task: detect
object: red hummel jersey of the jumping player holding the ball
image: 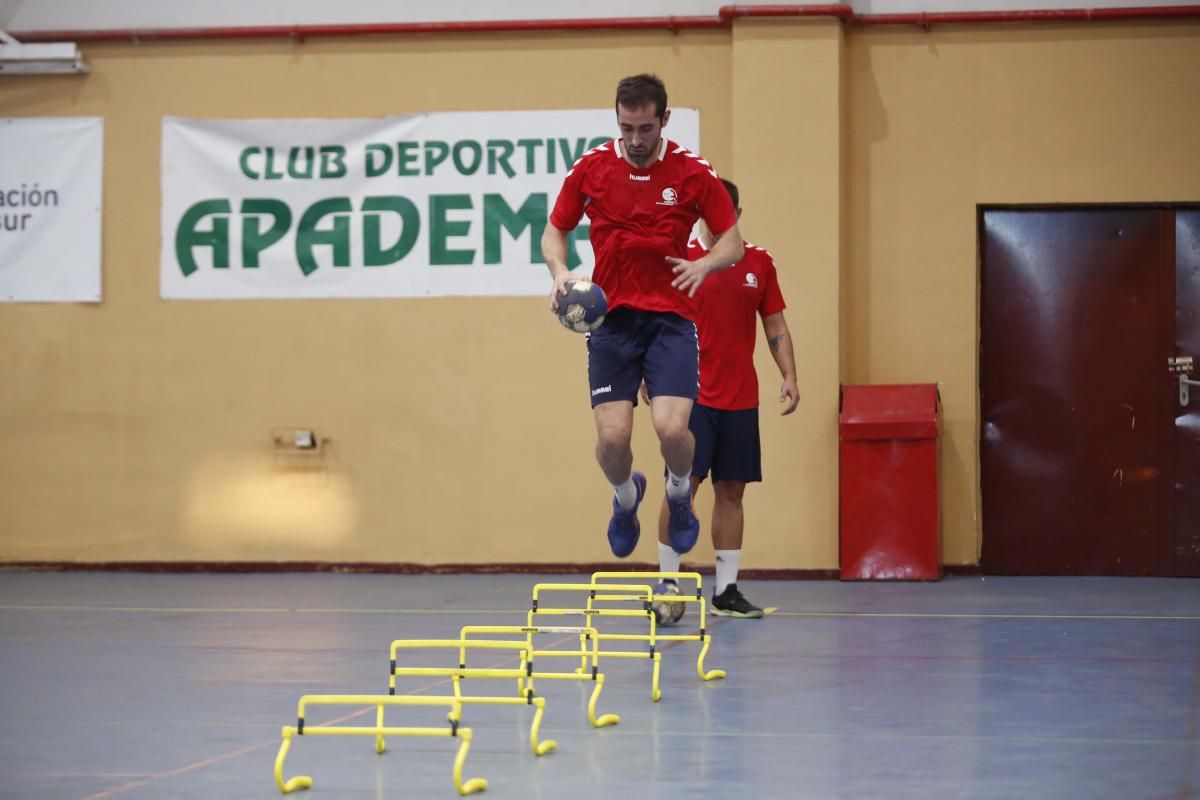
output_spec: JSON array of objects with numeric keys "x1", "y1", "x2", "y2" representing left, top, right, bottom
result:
[{"x1": 550, "y1": 139, "x2": 737, "y2": 319}]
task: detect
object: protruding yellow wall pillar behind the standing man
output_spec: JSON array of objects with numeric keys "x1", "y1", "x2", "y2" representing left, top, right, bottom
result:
[{"x1": 733, "y1": 19, "x2": 842, "y2": 569}]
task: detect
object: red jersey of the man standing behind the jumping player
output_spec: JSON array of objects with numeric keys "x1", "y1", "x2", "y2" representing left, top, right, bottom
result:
[{"x1": 688, "y1": 242, "x2": 787, "y2": 411}]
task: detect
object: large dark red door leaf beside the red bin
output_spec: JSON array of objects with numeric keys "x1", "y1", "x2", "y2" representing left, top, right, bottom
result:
[{"x1": 979, "y1": 207, "x2": 1180, "y2": 575}]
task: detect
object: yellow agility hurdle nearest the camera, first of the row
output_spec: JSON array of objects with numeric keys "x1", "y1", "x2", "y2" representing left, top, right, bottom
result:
[{"x1": 275, "y1": 694, "x2": 487, "y2": 795}]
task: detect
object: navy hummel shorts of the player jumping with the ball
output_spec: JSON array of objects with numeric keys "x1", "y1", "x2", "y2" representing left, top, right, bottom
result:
[{"x1": 588, "y1": 307, "x2": 700, "y2": 408}]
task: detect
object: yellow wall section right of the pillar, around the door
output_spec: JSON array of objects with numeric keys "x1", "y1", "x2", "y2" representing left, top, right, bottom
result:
[{"x1": 845, "y1": 23, "x2": 1200, "y2": 564}]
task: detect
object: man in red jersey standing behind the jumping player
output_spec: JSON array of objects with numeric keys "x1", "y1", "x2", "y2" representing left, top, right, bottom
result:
[{"x1": 659, "y1": 180, "x2": 800, "y2": 619}]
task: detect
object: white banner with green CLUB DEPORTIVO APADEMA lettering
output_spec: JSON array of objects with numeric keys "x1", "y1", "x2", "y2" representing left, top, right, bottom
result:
[{"x1": 161, "y1": 108, "x2": 700, "y2": 299}]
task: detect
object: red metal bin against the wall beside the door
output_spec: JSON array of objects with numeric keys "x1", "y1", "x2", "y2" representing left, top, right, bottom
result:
[{"x1": 839, "y1": 384, "x2": 942, "y2": 581}]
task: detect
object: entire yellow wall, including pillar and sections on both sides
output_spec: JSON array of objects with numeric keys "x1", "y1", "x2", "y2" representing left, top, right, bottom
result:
[{"x1": 0, "y1": 20, "x2": 1200, "y2": 569}]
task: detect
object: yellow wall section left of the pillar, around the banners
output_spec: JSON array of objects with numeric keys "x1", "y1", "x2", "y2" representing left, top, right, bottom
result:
[{"x1": 0, "y1": 31, "x2": 730, "y2": 563}]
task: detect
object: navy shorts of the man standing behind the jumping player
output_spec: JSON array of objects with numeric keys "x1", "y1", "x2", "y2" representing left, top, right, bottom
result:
[{"x1": 688, "y1": 403, "x2": 762, "y2": 483}]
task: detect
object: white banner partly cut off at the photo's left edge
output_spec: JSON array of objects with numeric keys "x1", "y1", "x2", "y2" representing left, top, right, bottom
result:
[{"x1": 0, "y1": 116, "x2": 104, "y2": 302}]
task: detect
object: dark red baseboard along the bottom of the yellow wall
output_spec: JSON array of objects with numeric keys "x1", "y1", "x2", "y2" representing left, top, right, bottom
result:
[{"x1": 0, "y1": 561, "x2": 982, "y2": 581}]
